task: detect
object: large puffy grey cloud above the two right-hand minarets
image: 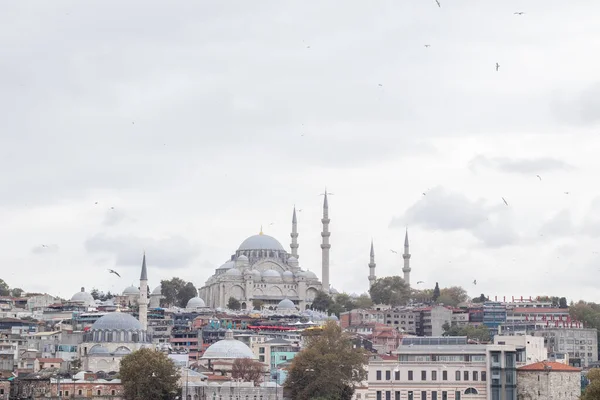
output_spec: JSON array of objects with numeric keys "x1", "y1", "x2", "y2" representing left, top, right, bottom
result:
[{"x1": 390, "y1": 187, "x2": 518, "y2": 247}]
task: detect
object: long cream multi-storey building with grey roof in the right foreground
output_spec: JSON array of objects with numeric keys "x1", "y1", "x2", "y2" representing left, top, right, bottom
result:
[{"x1": 368, "y1": 337, "x2": 517, "y2": 400}]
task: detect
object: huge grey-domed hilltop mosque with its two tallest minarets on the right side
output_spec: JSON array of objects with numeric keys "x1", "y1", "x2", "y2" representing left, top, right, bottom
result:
[{"x1": 199, "y1": 193, "x2": 333, "y2": 310}]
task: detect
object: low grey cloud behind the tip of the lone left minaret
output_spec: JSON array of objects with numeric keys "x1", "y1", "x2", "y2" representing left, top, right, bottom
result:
[{"x1": 85, "y1": 234, "x2": 199, "y2": 269}]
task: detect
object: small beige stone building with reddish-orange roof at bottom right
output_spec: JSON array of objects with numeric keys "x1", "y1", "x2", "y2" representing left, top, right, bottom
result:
[{"x1": 517, "y1": 361, "x2": 581, "y2": 400}]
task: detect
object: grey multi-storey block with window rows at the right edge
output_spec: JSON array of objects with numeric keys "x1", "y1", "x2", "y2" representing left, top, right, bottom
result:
[{"x1": 533, "y1": 327, "x2": 598, "y2": 368}]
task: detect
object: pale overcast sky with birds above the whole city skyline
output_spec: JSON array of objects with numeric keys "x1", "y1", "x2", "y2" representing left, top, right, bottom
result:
[{"x1": 0, "y1": 0, "x2": 600, "y2": 301}]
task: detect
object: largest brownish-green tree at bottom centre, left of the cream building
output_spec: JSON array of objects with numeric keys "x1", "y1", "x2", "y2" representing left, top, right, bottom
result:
[{"x1": 285, "y1": 322, "x2": 368, "y2": 400}]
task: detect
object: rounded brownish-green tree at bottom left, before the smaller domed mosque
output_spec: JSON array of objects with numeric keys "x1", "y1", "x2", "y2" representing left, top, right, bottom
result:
[{"x1": 119, "y1": 349, "x2": 179, "y2": 400}]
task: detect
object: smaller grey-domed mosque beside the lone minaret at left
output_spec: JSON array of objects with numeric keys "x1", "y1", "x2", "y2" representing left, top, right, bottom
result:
[{"x1": 79, "y1": 312, "x2": 152, "y2": 372}]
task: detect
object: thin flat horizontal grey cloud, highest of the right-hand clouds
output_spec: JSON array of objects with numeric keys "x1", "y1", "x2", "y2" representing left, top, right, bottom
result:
[{"x1": 469, "y1": 154, "x2": 573, "y2": 175}]
